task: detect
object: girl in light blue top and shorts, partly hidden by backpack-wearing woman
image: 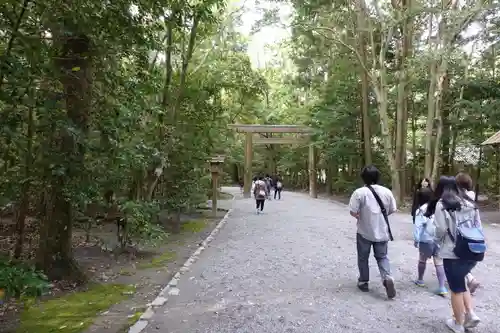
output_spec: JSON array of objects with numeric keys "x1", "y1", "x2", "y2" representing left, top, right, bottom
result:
[{"x1": 413, "y1": 188, "x2": 448, "y2": 296}]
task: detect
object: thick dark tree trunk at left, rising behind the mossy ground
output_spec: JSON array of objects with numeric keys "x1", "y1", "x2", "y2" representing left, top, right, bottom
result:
[{"x1": 36, "y1": 31, "x2": 92, "y2": 282}]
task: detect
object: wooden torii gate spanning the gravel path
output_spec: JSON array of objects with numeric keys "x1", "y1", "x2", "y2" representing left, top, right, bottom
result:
[{"x1": 229, "y1": 124, "x2": 318, "y2": 198}]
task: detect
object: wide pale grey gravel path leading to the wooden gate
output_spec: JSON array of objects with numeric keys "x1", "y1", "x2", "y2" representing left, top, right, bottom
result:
[{"x1": 145, "y1": 189, "x2": 500, "y2": 333}]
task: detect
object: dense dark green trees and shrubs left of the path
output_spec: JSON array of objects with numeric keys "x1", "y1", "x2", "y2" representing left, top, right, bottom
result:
[{"x1": 0, "y1": 0, "x2": 266, "y2": 287}]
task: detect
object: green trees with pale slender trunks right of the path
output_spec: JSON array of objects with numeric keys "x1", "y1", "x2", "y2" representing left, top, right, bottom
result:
[{"x1": 272, "y1": 0, "x2": 500, "y2": 202}]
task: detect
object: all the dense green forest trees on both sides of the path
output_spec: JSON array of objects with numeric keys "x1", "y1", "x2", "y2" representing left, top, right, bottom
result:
[{"x1": 0, "y1": 0, "x2": 500, "y2": 281}]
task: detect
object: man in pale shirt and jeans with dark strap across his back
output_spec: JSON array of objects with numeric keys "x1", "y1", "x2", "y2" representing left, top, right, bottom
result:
[{"x1": 349, "y1": 165, "x2": 396, "y2": 299}]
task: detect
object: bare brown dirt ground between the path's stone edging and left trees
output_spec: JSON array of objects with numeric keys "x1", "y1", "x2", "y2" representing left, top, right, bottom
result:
[{"x1": 0, "y1": 205, "x2": 227, "y2": 333}]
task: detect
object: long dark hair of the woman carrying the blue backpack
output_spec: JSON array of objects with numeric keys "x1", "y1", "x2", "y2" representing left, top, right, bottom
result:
[{"x1": 425, "y1": 176, "x2": 475, "y2": 217}]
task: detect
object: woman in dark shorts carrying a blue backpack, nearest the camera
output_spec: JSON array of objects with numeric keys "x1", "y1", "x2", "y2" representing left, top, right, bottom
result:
[{"x1": 425, "y1": 177, "x2": 486, "y2": 333}]
